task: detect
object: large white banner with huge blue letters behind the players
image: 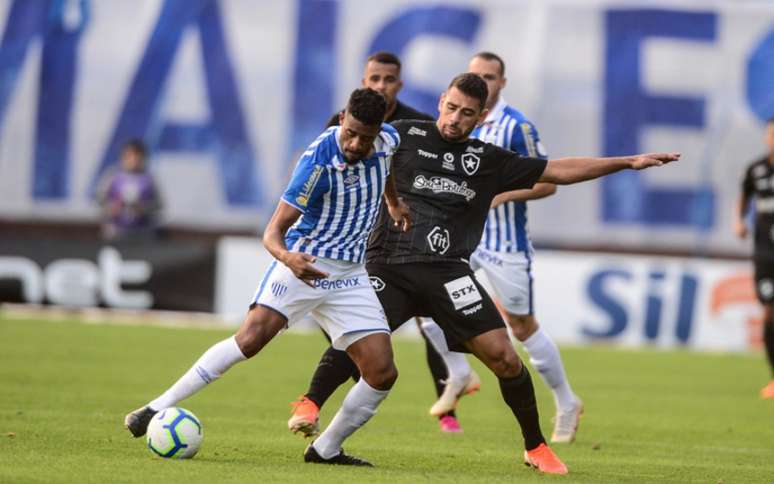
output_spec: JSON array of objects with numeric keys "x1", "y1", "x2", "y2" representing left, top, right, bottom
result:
[{"x1": 0, "y1": 0, "x2": 774, "y2": 255}]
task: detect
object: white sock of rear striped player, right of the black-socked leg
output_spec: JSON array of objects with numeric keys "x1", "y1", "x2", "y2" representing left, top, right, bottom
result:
[{"x1": 522, "y1": 327, "x2": 576, "y2": 411}]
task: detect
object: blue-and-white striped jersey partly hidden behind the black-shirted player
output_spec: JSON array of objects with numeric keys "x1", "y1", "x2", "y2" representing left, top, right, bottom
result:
[{"x1": 470, "y1": 98, "x2": 548, "y2": 253}]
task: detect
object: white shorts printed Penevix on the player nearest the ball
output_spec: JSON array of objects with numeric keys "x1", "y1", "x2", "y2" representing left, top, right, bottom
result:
[{"x1": 253, "y1": 257, "x2": 390, "y2": 350}]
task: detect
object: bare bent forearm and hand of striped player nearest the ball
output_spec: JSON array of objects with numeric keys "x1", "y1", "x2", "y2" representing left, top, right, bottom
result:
[{"x1": 263, "y1": 201, "x2": 328, "y2": 287}]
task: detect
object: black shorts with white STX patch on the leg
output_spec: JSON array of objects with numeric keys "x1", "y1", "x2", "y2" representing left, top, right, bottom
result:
[{"x1": 366, "y1": 261, "x2": 505, "y2": 351}]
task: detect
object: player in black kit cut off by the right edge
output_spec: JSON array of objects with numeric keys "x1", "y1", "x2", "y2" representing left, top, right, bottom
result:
[{"x1": 734, "y1": 118, "x2": 774, "y2": 399}]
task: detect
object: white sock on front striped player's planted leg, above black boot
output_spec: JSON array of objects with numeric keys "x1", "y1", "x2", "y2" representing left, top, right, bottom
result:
[{"x1": 314, "y1": 378, "x2": 390, "y2": 459}]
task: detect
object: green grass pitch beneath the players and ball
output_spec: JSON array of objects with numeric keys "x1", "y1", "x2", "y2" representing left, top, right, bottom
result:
[{"x1": 0, "y1": 316, "x2": 774, "y2": 483}]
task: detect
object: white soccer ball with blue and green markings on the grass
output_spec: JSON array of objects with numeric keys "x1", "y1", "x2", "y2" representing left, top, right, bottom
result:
[{"x1": 148, "y1": 407, "x2": 204, "y2": 459}]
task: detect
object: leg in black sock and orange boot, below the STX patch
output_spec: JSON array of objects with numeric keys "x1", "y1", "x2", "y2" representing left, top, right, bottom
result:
[{"x1": 466, "y1": 328, "x2": 567, "y2": 474}]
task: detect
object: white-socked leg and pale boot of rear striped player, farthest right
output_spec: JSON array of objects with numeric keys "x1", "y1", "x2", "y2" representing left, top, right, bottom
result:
[{"x1": 498, "y1": 306, "x2": 583, "y2": 443}]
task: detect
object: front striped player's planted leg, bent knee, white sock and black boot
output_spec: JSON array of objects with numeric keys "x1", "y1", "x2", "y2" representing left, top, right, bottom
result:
[{"x1": 304, "y1": 332, "x2": 398, "y2": 466}]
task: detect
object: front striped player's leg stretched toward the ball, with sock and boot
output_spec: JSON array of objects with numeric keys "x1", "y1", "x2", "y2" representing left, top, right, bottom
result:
[{"x1": 124, "y1": 305, "x2": 288, "y2": 437}]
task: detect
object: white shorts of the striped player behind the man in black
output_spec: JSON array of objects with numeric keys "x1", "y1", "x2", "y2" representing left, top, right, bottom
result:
[{"x1": 470, "y1": 247, "x2": 533, "y2": 316}]
